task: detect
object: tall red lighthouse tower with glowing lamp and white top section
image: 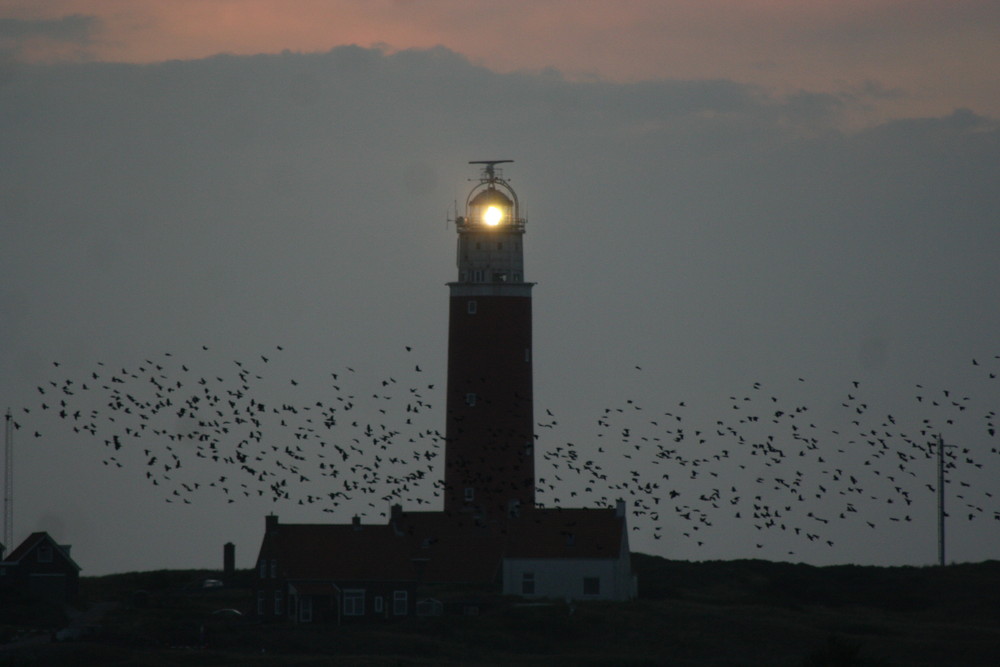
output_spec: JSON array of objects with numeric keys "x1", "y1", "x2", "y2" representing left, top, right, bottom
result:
[{"x1": 444, "y1": 160, "x2": 535, "y2": 517}]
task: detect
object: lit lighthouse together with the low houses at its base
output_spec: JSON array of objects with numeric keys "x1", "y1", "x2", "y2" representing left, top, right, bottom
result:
[{"x1": 254, "y1": 160, "x2": 636, "y2": 623}]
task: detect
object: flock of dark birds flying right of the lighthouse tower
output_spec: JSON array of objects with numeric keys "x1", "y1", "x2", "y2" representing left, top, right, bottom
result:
[{"x1": 539, "y1": 356, "x2": 1000, "y2": 555}]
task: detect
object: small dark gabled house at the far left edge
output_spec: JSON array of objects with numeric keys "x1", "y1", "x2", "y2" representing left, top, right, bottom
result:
[{"x1": 0, "y1": 532, "x2": 80, "y2": 601}]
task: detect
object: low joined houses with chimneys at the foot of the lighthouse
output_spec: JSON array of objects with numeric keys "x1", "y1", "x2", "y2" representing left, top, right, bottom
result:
[{"x1": 254, "y1": 503, "x2": 635, "y2": 623}]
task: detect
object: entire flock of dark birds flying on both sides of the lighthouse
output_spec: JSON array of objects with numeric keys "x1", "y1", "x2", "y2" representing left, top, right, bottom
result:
[{"x1": 15, "y1": 346, "x2": 1000, "y2": 554}]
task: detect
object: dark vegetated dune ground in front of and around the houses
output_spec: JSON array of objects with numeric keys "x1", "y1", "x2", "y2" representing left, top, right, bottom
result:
[{"x1": 0, "y1": 554, "x2": 1000, "y2": 667}]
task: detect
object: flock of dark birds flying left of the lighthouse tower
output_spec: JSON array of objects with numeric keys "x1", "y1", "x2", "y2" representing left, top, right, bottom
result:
[{"x1": 16, "y1": 346, "x2": 442, "y2": 514}]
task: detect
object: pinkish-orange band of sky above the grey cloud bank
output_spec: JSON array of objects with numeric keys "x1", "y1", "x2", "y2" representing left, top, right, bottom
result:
[{"x1": 0, "y1": 0, "x2": 1000, "y2": 118}]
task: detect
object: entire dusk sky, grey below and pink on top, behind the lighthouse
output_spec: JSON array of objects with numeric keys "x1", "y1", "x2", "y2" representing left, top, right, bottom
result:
[{"x1": 0, "y1": 0, "x2": 1000, "y2": 575}]
